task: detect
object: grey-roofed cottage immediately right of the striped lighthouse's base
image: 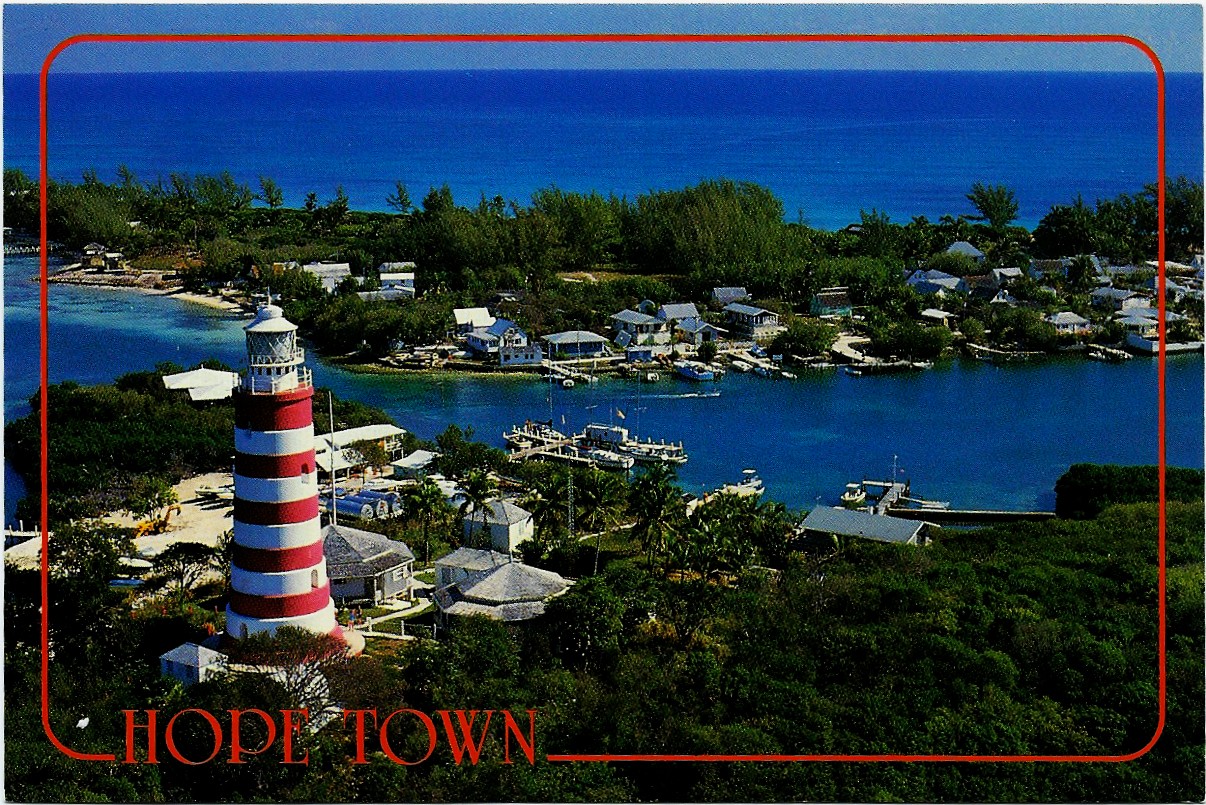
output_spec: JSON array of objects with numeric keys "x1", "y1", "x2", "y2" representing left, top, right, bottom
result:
[{"x1": 322, "y1": 524, "x2": 415, "y2": 603}]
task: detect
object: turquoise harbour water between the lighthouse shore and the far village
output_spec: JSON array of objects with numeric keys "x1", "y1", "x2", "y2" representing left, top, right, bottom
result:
[{"x1": 5, "y1": 258, "x2": 1204, "y2": 519}]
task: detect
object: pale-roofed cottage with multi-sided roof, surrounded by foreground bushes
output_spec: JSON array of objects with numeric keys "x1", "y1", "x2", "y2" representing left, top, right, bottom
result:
[{"x1": 432, "y1": 548, "x2": 573, "y2": 624}]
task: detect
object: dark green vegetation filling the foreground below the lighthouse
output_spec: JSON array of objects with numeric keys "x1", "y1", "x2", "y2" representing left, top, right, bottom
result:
[{"x1": 5, "y1": 487, "x2": 1206, "y2": 801}]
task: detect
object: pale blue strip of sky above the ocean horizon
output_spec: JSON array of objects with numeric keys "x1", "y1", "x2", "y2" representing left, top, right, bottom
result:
[{"x1": 2, "y1": 2, "x2": 1202, "y2": 74}]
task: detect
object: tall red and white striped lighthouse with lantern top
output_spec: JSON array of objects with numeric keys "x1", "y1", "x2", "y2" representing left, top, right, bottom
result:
[{"x1": 227, "y1": 304, "x2": 341, "y2": 640}]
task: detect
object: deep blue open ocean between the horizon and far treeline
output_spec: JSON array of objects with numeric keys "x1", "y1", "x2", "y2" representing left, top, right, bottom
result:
[{"x1": 4, "y1": 70, "x2": 1202, "y2": 228}]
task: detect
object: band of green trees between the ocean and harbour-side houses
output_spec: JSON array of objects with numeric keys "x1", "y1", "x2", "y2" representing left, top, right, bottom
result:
[{"x1": 5, "y1": 168, "x2": 1202, "y2": 356}]
